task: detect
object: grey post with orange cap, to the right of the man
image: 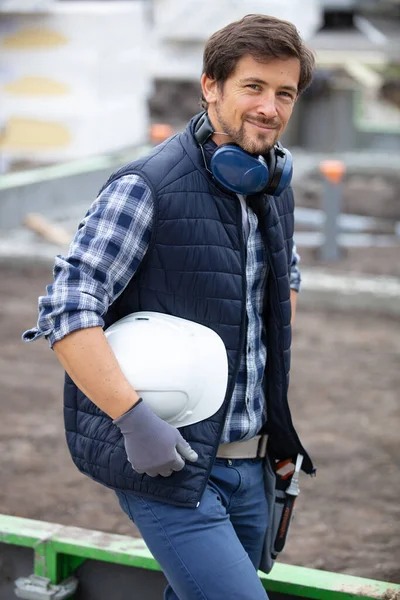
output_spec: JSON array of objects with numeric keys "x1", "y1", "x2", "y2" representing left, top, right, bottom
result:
[{"x1": 319, "y1": 160, "x2": 345, "y2": 261}]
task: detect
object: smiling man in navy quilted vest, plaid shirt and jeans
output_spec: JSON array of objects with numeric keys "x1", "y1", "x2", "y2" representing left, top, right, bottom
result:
[{"x1": 24, "y1": 15, "x2": 314, "y2": 600}]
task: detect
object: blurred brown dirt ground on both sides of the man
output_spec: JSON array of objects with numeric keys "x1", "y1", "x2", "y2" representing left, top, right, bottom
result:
[{"x1": 0, "y1": 264, "x2": 400, "y2": 583}]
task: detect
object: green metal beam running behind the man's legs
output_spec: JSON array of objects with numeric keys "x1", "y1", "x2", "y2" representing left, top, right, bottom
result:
[{"x1": 0, "y1": 515, "x2": 400, "y2": 600}]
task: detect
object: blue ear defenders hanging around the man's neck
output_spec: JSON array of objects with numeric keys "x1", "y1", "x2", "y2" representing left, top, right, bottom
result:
[{"x1": 194, "y1": 113, "x2": 293, "y2": 196}]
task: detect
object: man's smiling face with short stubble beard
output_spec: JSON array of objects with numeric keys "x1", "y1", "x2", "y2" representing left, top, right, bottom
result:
[{"x1": 201, "y1": 55, "x2": 300, "y2": 154}]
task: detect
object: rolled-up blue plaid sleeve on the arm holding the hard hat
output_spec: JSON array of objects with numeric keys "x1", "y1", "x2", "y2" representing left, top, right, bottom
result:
[{"x1": 22, "y1": 175, "x2": 154, "y2": 346}]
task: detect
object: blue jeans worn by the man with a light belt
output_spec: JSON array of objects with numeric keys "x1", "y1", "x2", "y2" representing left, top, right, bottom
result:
[{"x1": 117, "y1": 458, "x2": 268, "y2": 600}]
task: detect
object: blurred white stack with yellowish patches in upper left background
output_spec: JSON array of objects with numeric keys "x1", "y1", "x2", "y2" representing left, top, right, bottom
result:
[{"x1": 0, "y1": 1, "x2": 150, "y2": 162}]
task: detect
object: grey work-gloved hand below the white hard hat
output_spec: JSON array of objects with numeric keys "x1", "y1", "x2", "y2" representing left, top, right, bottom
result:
[{"x1": 113, "y1": 399, "x2": 198, "y2": 477}]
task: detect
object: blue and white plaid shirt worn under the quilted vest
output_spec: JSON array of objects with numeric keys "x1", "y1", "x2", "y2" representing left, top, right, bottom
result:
[{"x1": 23, "y1": 175, "x2": 300, "y2": 443}]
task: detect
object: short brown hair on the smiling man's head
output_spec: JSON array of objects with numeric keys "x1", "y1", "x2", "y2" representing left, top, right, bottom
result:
[{"x1": 201, "y1": 15, "x2": 315, "y2": 109}]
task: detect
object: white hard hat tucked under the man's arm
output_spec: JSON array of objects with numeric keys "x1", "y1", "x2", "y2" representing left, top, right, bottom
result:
[{"x1": 105, "y1": 312, "x2": 228, "y2": 427}]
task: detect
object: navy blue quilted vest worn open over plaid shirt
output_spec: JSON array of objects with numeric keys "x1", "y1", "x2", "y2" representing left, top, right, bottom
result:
[{"x1": 64, "y1": 116, "x2": 313, "y2": 507}]
